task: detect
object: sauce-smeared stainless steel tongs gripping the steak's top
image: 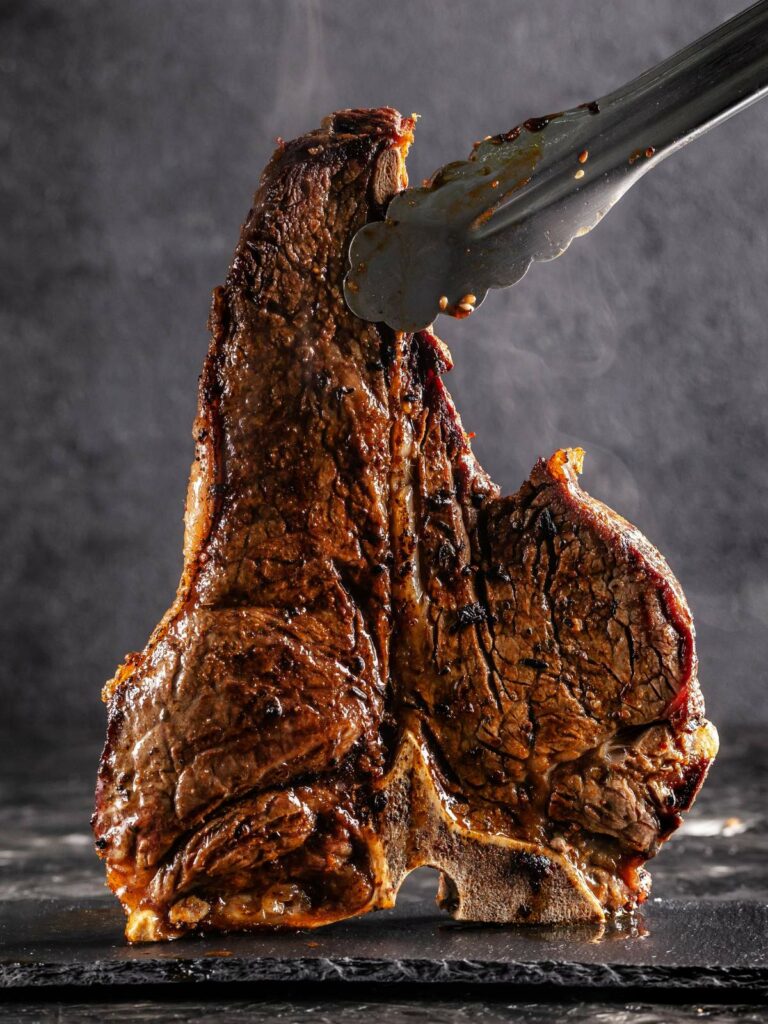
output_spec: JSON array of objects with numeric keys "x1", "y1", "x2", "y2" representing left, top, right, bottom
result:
[{"x1": 344, "y1": 0, "x2": 768, "y2": 331}]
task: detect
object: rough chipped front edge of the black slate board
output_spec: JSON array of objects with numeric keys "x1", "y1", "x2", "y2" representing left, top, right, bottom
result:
[{"x1": 0, "y1": 956, "x2": 768, "y2": 995}]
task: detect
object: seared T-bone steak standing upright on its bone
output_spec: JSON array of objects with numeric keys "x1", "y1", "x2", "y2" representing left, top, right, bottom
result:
[{"x1": 93, "y1": 109, "x2": 717, "y2": 941}]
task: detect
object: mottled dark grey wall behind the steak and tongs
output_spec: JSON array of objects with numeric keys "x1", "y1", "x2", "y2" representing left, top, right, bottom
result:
[{"x1": 0, "y1": 0, "x2": 768, "y2": 745}]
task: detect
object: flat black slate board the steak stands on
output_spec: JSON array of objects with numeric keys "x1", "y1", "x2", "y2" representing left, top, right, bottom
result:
[{"x1": 0, "y1": 888, "x2": 768, "y2": 993}]
